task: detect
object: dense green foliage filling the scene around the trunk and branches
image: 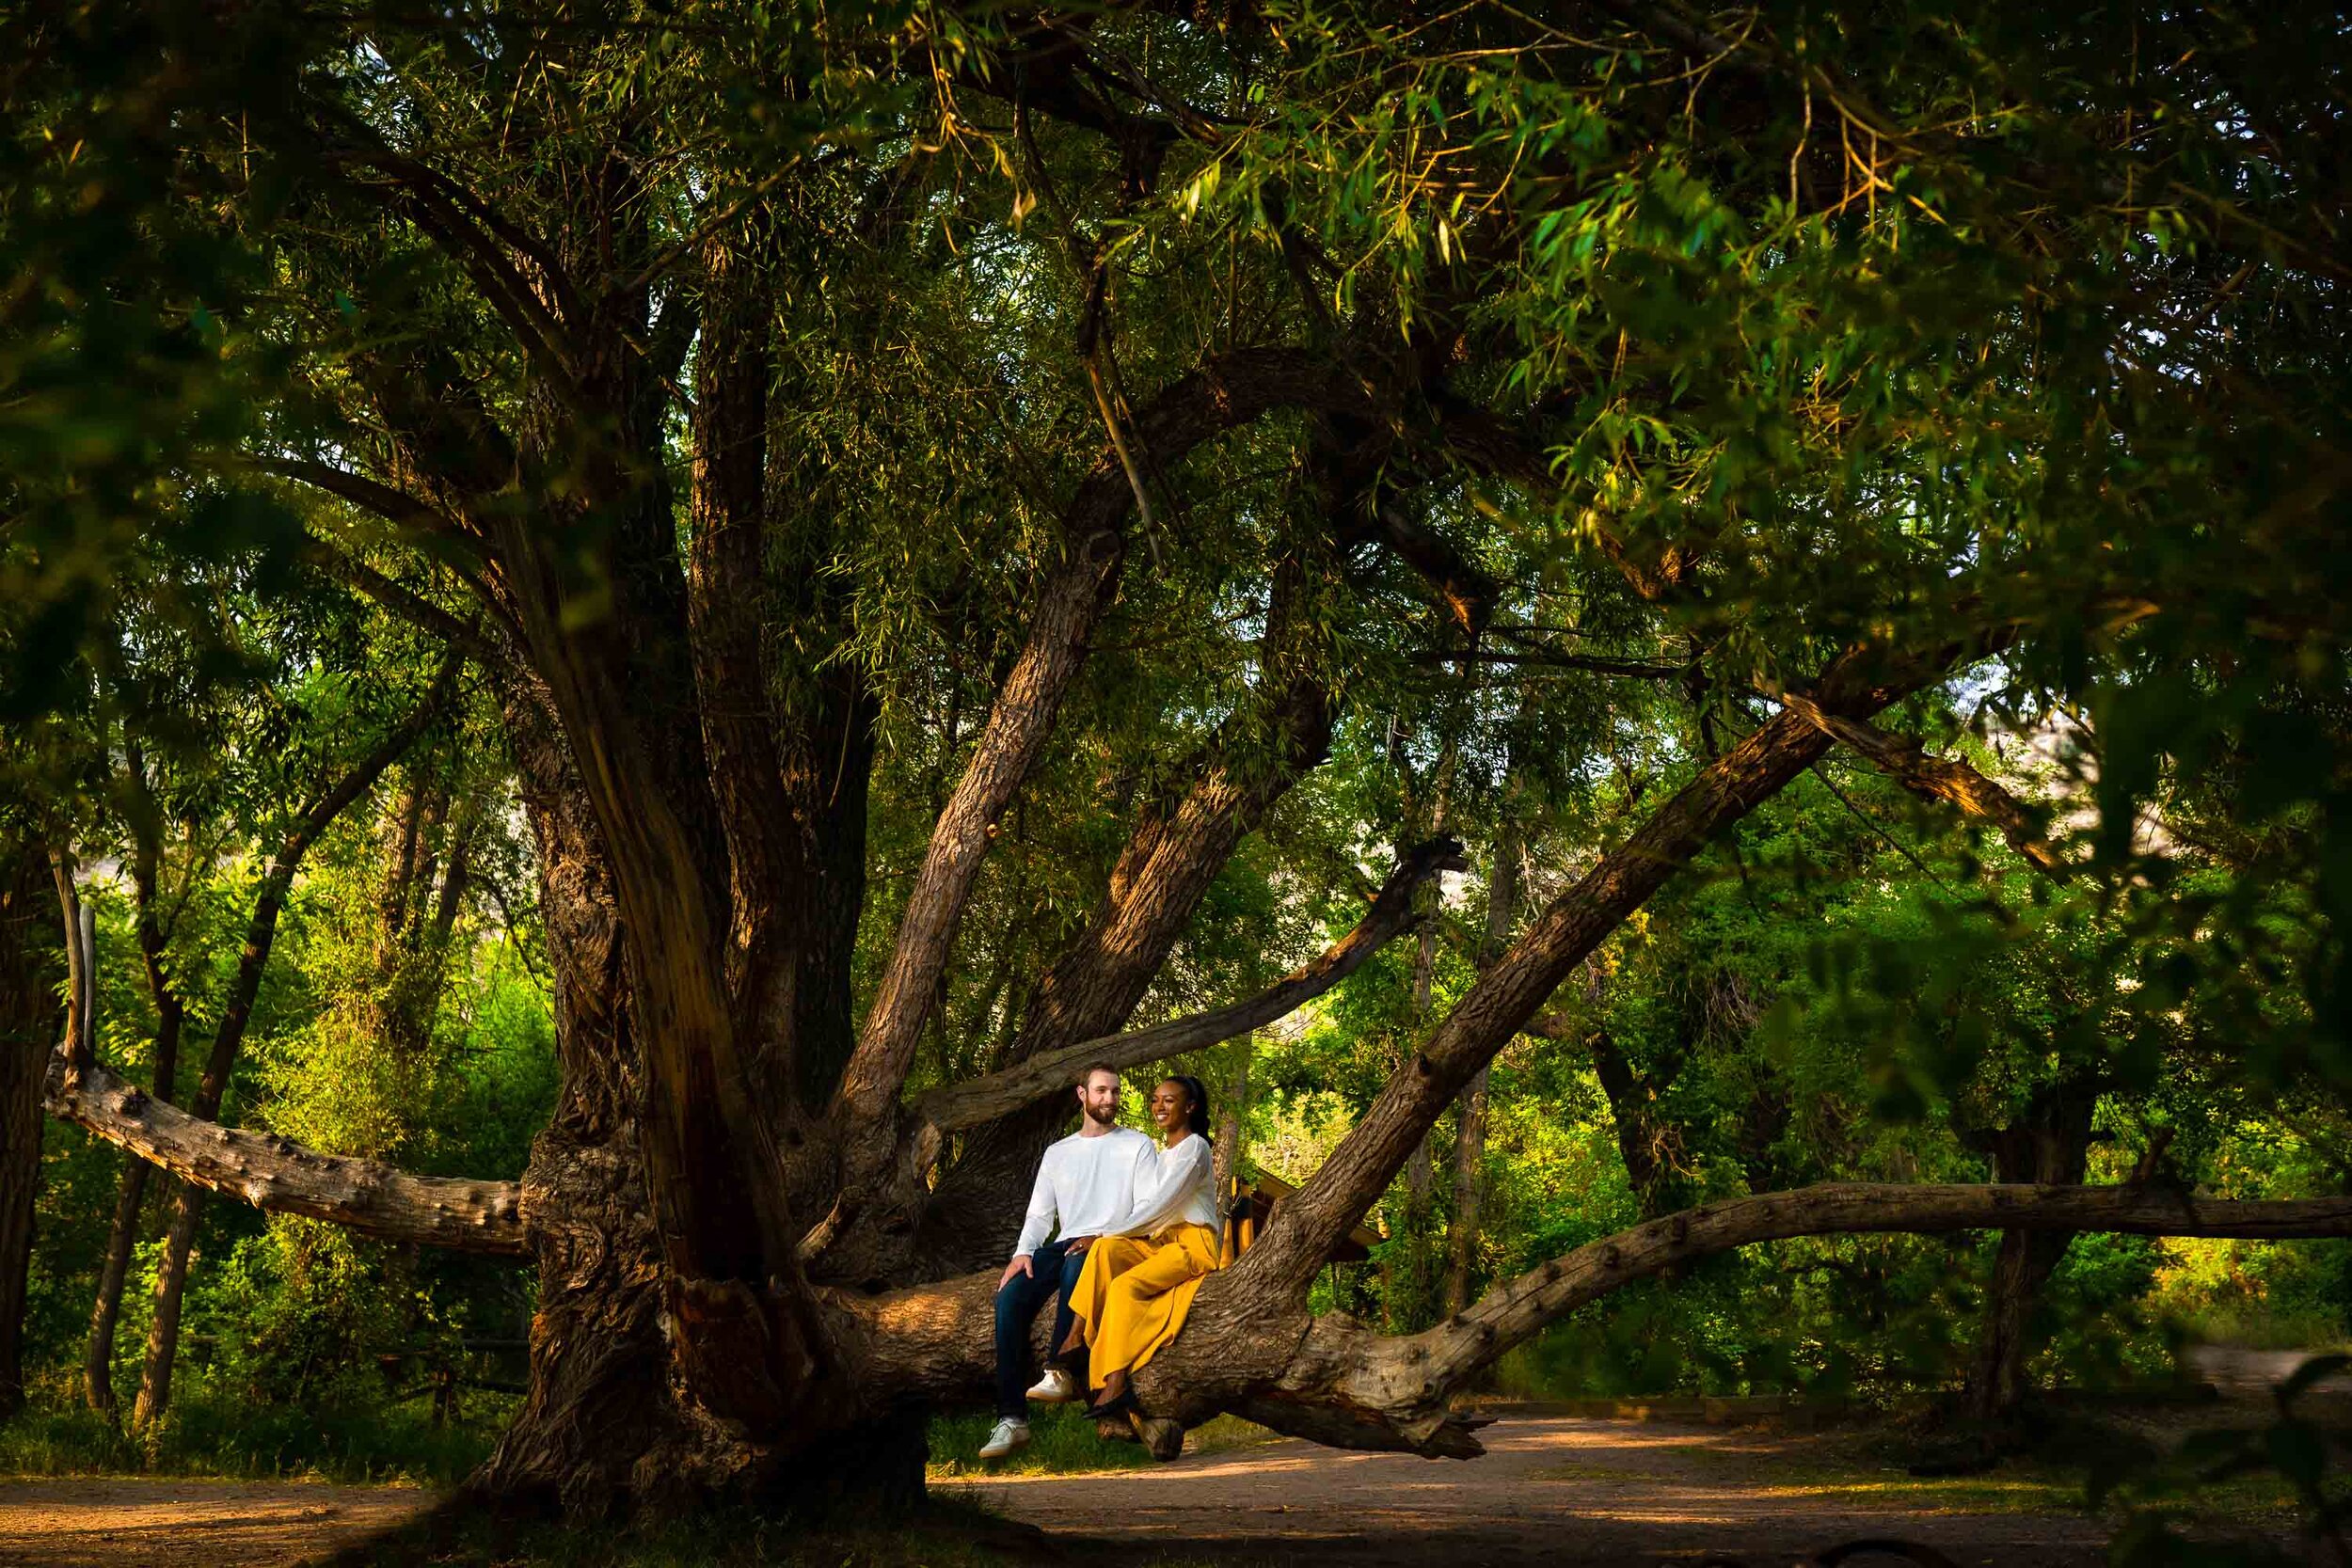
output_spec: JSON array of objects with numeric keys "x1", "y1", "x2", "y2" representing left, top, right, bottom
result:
[{"x1": 0, "y1": 0, "x2": 2352, "y2": 1560}]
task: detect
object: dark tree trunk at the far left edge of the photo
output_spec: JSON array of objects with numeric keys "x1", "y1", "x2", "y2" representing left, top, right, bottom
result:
[{"x1": 0, "y1": 847, "x2": 64, "y2": 1420}]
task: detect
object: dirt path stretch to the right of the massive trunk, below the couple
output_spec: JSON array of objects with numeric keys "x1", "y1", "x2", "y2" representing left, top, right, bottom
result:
[{"x1": 969, "y1": 1418, "x2": 2154, "y2": 1568}]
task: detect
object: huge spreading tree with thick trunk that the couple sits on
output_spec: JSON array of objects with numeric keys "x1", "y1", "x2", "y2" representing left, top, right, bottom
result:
[{"x1": 5, "y1": 2, "x2": 2352, "y2": 1510}]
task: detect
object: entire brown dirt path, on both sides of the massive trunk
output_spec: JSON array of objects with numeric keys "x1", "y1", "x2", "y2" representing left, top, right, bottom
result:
[{"x1": 0, "y1": 1411, "x2": 2296, "y2": 1568}]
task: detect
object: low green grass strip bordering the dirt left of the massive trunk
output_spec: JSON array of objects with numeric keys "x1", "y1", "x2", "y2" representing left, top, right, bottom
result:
[{"x1": 0, "y1": 1380, "x2": 511, "y2": 1486}]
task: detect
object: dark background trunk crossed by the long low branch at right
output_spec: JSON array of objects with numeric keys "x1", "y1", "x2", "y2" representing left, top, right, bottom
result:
[{"x1": 1960, "y1": 1077, "x2": 2098, "y2": 1420}]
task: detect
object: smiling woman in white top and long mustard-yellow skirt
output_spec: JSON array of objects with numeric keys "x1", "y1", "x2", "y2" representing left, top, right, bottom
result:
[{"x1": 1063, "y1": 1079, "x2": 1218, "y2": 1418}]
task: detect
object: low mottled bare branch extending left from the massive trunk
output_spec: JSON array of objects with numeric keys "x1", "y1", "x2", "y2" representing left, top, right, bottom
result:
[{"x1": 45, "y1": 1055, "x2": 527, "y2": 1258}]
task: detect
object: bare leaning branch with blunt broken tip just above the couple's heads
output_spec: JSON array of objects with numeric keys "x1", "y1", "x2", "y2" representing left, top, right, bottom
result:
[{"x1": 915, "y1": 839, "x2": 1470, "y2": 1133}]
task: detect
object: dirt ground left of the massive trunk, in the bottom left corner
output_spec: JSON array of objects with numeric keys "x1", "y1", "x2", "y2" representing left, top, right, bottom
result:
[{"x1": 0, "y1": 1479, "x2": 436, "y2": 1568}]
